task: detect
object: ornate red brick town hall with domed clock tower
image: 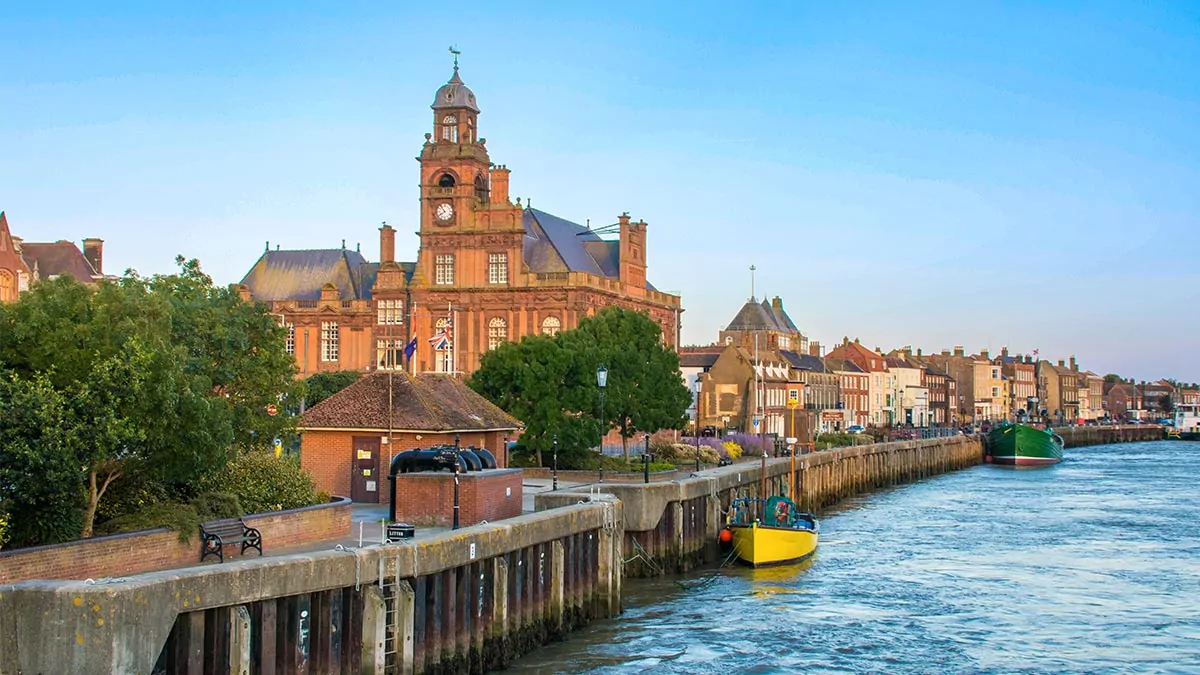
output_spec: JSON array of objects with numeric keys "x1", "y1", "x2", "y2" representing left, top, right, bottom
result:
[{"x1": 240, "y1": 65, "x2": 683, "y2": 375}]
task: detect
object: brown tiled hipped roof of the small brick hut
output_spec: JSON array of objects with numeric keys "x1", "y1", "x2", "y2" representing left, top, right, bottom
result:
[{"x1": 299, "y1": 371, "x2": 523, "y2": 431}]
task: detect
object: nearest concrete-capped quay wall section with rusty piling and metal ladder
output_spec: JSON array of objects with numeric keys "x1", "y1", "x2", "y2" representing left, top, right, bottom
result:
[{"x1": 0, "y1": 496, "x2": 624, "y2": 675}]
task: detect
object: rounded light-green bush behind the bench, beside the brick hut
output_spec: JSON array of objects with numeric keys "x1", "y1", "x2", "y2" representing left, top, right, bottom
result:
[{"x1": 202, "y1": 450, "x2": 317, "y2": 513}]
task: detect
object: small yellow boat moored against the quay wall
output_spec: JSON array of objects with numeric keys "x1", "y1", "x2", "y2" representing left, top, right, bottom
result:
[{"x1": 720, "y1": 453, "x2": 820, "y2": 567}]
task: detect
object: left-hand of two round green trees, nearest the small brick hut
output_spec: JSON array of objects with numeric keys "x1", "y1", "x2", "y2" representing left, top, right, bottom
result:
[{"x1": 467, "y1": 335, "x2": 599, "y2": 466}]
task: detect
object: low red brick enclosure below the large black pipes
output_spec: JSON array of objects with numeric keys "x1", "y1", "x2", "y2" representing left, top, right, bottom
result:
[{"x1": 396, "y1": 468, "x2": 523, "y2": 527}]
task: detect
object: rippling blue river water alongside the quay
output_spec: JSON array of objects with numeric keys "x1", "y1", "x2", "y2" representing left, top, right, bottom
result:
[{"x1": 509, "y1": 441, "x2": 1200, "y2": 674}]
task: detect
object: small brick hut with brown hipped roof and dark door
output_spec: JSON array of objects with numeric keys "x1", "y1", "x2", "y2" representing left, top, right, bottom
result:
[{"x1": 299, "y1": 371, "x2": 522, "y2": 503}]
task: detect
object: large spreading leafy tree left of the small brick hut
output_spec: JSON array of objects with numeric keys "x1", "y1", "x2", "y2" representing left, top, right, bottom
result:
[{"x1": 0, "y1": 258, "x2": 295, "y2": 543}]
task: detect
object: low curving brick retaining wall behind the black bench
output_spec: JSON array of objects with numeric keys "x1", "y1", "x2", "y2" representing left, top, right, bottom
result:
[{"x1": 0, "y1": 501, "x2": 350, "y2": 585}]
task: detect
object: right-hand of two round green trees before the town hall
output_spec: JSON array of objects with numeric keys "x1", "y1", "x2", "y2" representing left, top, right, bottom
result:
[{"x1": 560, "y1": 307, "x2": 691, "y2": 462}]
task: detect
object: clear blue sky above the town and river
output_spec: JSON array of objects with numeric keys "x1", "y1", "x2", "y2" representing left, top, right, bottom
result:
[{"x1": 0, "y1": 0, "x2": 1200, "y2": 381}]
